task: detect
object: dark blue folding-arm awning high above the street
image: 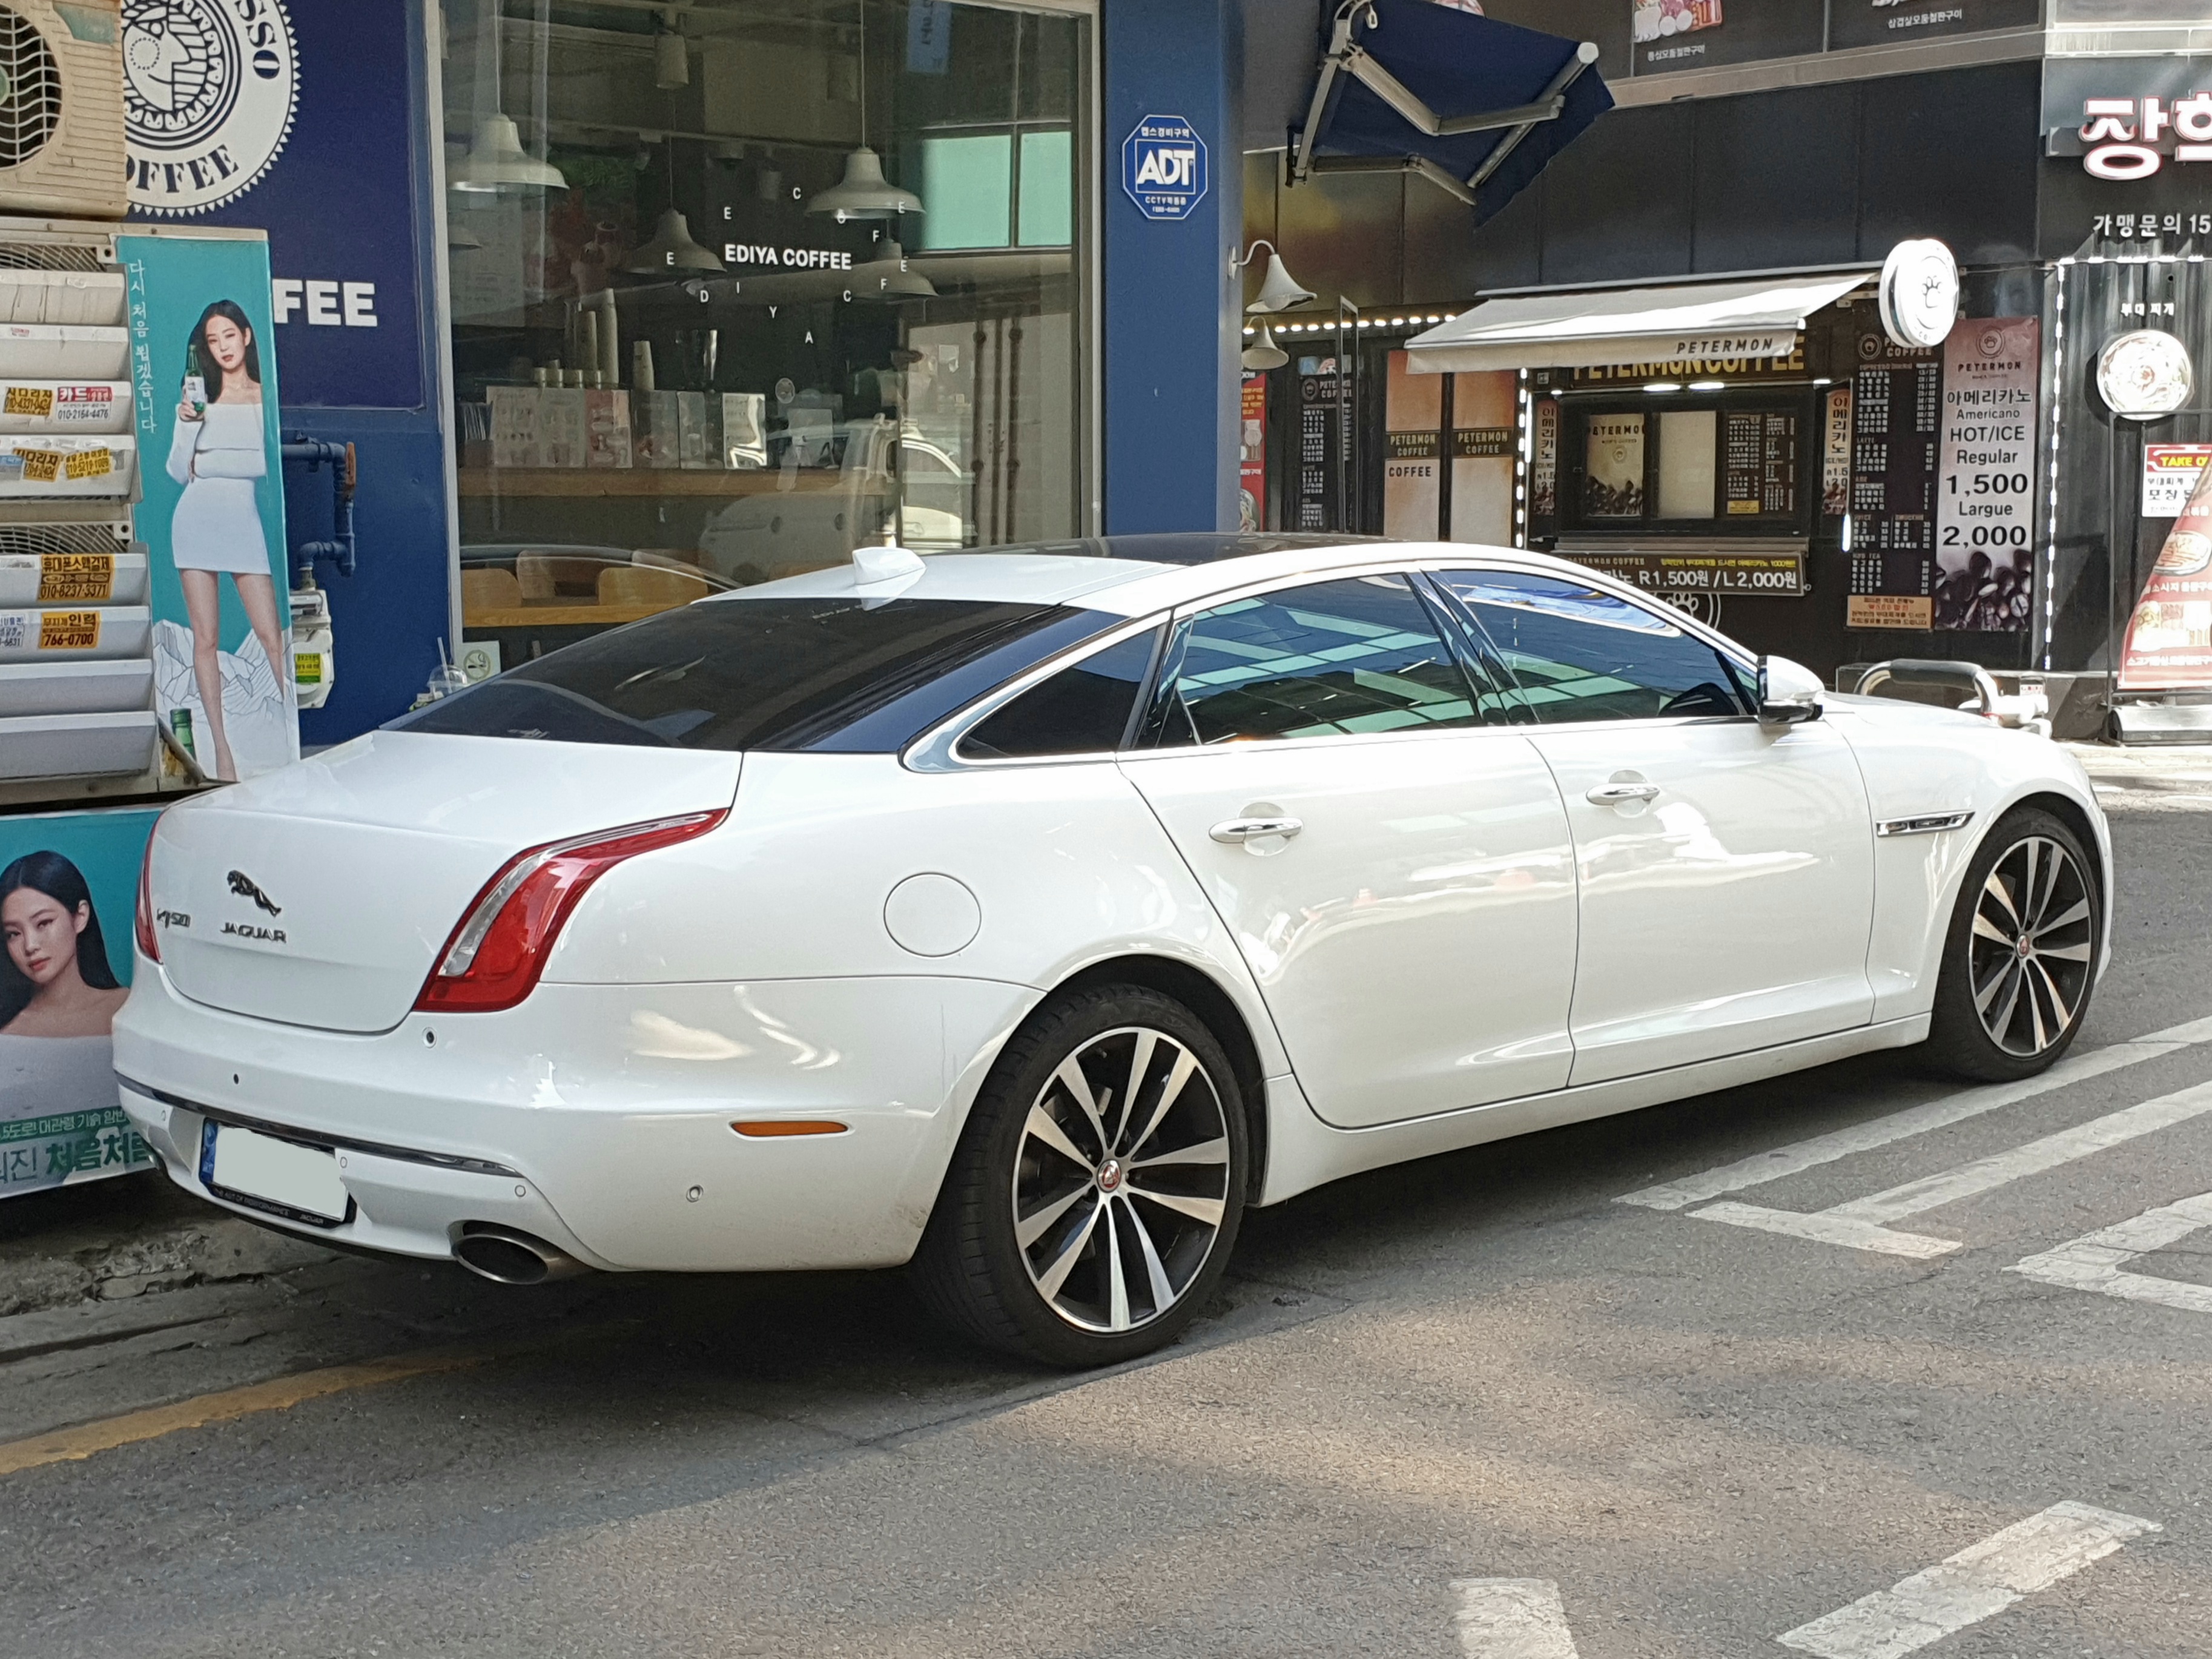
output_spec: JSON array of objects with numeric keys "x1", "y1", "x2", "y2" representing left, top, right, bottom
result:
[{"x1": 1292, "y1": 0, "x2": 1613, "y2": 223}]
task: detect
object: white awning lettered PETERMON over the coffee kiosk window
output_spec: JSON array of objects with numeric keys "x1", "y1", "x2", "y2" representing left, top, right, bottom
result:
[{"x1": 1405, "y1": 270, "x2": 1876, "y2": 374}]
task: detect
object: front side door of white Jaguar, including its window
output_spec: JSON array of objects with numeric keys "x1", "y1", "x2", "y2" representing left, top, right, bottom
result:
[{"x1": 1436, "y1": 569, "x2": 1874, "y2": 1084}]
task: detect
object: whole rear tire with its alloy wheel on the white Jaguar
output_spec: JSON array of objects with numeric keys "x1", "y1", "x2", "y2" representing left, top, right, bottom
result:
[{"x1": 914, "y1": 985, "x2": 1250, "y2": 1369}]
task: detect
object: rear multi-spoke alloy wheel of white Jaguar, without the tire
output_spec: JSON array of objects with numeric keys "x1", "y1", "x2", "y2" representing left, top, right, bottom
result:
[{"x1": 1013, "y1": 1026, "x2": 1232, "y2": 1331}]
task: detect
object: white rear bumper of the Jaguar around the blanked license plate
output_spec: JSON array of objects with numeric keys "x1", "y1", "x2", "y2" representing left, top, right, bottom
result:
[{"x1": 115, "y1": 973, "x2": 1037, "y2": 1272}]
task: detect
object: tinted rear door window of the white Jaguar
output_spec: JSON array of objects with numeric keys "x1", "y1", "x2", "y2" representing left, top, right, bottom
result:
[{"x1": 1155, "y1": 575, "x2": 1482, "y2": 745}]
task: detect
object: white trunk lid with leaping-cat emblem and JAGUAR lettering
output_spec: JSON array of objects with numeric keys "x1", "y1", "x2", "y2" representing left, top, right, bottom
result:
[{"x1": 153, "y1": 732, "x2": 741, "y2": 1031}]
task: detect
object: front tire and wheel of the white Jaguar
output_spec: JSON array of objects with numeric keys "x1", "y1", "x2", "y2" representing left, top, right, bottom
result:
[{"x1": 1927, "y1": 807, "x2": 2104, "y2": 1084}]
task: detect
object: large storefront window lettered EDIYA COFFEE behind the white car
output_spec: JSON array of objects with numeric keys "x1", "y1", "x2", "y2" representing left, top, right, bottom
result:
[{"x1": 444, "y1": 0, "x2": 1093, "y2": 666}]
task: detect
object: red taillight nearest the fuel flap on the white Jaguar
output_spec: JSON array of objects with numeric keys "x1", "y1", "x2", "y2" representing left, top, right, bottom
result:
[{"x1": 416, "y1": 810, "x2": 730, "y2": 1013}]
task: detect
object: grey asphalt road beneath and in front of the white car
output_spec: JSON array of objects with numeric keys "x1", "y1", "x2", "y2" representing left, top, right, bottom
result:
[{"x1": 0, "y1": 779, "x2": 2212, "y2": 1659}]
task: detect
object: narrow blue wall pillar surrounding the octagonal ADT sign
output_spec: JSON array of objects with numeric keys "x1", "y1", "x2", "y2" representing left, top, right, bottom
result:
[{"x1": 1100, "y1": 0, "x2": 1243, "y2": 535}]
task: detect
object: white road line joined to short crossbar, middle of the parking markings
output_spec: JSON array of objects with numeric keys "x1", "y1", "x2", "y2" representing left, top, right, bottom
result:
[{"x1": 1690, "y1": 1084, "x2": 2212, "y2": 1261}]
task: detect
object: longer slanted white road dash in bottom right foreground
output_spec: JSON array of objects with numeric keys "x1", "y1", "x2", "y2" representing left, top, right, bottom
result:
[{"x1": 1774, "y1": 1504, "x2": 2165, "y2": 1659}]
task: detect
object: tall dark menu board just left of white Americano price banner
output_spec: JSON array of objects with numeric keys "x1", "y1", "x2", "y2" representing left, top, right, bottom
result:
[{"x1": 1845, "y1": 328, "x2": 1942, "y2": 630}]
